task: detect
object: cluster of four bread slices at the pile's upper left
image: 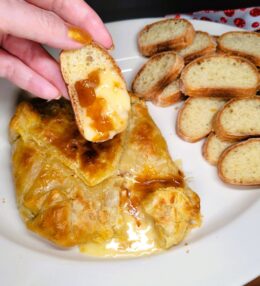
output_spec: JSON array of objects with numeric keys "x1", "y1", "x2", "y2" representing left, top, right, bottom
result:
[{"x1": 132, "y1": 19, "x2": 216, "y2": 107}]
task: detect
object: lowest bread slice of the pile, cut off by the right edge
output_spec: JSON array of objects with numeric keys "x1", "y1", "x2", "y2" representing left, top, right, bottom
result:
[{"x1": 218, "y1": 138, "x2": 260, "y2": 186}]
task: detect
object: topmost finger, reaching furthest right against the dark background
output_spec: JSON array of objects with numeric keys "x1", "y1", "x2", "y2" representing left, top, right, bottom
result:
[{"x1": 27, "y1": 0, "x2": 113, "y2": 48}]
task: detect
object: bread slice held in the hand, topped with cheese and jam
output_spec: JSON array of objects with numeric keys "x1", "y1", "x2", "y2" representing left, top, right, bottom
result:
[{"x1": 60, "y1": 43, "x2": 130, "y2": 142}]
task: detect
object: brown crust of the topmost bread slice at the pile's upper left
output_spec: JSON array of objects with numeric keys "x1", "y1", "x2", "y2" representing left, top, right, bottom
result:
[{"x1": 138, "y1": 19, "x2": 195, "y2": 57}]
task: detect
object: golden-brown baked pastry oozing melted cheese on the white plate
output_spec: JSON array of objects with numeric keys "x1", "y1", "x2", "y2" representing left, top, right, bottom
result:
[{"x1": 10, "y1": 96, "x2": 200, "y2": 256}]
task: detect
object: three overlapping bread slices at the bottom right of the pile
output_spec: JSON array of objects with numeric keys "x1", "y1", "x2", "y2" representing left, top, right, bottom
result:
[{"x1": 203, "y1": 96, "x2": 260, "y2": 185}]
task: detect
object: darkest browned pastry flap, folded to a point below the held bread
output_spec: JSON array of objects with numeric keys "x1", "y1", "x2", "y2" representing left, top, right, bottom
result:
[{"x1": 11, "y1": 100, "x2": 124, "y2": 186}]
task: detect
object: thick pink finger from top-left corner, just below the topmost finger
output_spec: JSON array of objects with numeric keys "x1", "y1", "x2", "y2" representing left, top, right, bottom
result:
[{"x1": 0, "y1": 0, "x2": 82, "y2": 49}]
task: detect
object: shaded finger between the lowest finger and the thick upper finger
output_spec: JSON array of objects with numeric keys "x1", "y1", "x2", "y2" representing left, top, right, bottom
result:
[{"x1": 2, "y1": 35, "x2": 68, "y2": 98}]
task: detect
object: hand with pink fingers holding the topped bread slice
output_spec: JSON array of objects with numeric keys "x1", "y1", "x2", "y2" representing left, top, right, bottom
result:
[{"x1": 0, "y1": 0, "x2": 112, "y2": 99}]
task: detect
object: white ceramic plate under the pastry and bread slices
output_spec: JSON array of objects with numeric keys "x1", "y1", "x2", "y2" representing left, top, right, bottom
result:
[{"x1": 0, "y1": 19, "x2": 260, "y2": 286}]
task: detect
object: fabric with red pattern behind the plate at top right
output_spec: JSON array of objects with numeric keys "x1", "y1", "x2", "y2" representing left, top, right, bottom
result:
[{"x1": 166, "y1": 7, "x2": 260, "y2": 31}]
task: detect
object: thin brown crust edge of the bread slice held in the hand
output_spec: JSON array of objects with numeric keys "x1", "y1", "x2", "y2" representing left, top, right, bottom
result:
[{"x1": 60, "y1": 42, "x2": 130, "y2": 142}]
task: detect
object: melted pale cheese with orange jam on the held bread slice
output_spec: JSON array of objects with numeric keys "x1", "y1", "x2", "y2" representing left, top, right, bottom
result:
[{"x1": 80, "y1": 69, "x2": 130, "y2": 142}]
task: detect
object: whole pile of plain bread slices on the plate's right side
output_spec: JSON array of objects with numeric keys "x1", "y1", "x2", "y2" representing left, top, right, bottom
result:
[{"x1": 132, "y1": 19, "x2": 260, "y2": 185}]
